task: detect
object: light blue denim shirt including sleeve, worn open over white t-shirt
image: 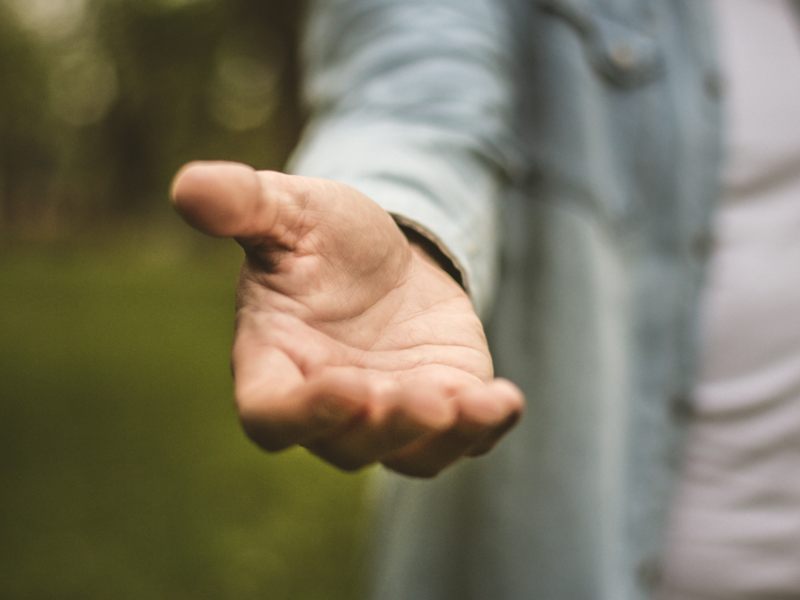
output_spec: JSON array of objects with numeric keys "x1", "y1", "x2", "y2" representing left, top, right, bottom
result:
[{"x1": 292, "y1": 0, "x2": 722, "y2": 600}]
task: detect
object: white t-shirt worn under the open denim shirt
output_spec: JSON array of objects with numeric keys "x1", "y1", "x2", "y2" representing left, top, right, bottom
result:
[{"x1": 662, "y1": 0, "x2": 800, "y2": 600}]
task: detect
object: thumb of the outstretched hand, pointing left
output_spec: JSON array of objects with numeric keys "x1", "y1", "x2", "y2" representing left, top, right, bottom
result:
[{"x1": 171, "y1": 161, "x2": 278, "y2": 237}]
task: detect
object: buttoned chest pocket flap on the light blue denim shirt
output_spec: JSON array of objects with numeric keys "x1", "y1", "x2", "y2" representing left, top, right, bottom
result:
[{"x1": 537, "y1": 0, "x2": 663, "y2": 88}]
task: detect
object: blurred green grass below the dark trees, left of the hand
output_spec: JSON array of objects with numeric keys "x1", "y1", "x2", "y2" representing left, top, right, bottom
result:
[{"x1": 0, "y1": 232, "x2": 374, "y2": 600}]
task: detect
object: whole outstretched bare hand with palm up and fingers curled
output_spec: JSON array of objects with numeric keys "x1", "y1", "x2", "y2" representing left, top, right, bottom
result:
[{"x1": 173, "y1": 162, "x2": 523, "y2": 477}]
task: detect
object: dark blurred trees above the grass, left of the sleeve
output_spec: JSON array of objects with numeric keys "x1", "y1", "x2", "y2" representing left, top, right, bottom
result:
[{"x1": 0, "y1": 0, "x2": 303, "y2": 232}]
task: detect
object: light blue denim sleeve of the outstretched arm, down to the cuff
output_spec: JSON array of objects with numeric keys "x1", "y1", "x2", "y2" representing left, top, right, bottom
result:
[{"x1": 289, "y1": 0, "x2": 516, "y2": 314}]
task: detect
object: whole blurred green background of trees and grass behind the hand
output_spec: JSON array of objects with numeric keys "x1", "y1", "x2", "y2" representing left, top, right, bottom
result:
[{"x1": 0, "y1": 0, "x2": 369, "y2": 600}]
